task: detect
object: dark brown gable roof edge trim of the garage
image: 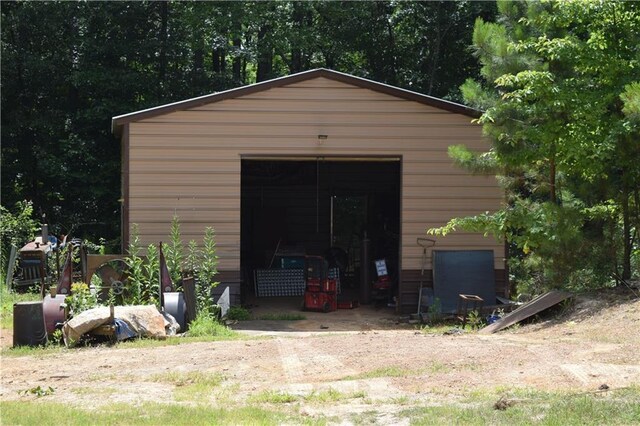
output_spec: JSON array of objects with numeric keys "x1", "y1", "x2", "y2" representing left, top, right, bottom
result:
[{"x1": 111, "y1": 68, "x2": 481, "y2": 135}]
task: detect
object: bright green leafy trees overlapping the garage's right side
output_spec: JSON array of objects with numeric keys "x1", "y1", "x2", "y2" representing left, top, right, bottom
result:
[{"x1": 429, "y1": 1, "x2": 640, "y2": 293}]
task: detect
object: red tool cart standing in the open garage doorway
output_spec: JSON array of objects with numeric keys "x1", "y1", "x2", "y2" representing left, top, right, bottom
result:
[{"x1": 303, "y1": 256, "x2": 338, "y2": 312}]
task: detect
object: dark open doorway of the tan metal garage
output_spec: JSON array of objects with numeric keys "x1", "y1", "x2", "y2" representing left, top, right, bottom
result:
[{"x1": 241, "y1": 157, "x2": 401, "y2": 303}]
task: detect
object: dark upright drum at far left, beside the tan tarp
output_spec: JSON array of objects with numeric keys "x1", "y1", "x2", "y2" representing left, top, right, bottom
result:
[{"x1": 13, "y1": 302, "x2": 47, "y2": 346}]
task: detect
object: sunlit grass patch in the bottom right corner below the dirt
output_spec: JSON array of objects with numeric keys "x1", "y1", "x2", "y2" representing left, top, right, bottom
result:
[{"x1": 400, "y1": 387, "x2": 640, "y2": 425}]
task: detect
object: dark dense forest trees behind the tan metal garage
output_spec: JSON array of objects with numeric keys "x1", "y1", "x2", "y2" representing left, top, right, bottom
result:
[{"x1": 0, "y1": 1, "x2": 495, "y2": 250}]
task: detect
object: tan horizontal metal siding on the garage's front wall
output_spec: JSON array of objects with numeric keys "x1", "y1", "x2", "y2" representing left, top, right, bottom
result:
[{"x1": 128, "y1": 78, "x2": 504, "y2": 270}]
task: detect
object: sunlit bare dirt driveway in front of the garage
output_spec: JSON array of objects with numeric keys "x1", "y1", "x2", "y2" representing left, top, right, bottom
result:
[{"x1": 0, "y1": 292, "x2": 640, "y2": 424}]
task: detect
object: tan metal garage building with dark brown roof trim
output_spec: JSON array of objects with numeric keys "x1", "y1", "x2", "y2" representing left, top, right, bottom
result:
[{"x1": 112, "y1": 69, "x2": 507, "y2": 312}]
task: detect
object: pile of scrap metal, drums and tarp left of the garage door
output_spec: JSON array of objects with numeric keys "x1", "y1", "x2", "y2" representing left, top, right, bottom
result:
[{"x1": 7, "y1": 226, "x2": 208, "y2": 346}]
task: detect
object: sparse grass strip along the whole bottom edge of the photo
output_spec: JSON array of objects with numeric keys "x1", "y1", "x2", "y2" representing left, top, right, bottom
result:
[{"x1": 0, "y1": 386, "x2": 640, "y2": 425}]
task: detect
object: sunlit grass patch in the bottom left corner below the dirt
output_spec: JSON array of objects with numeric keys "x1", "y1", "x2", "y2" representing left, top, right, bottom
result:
[{"x1": 0, "y1": 401, "x2": 316, "y2": 426}]
